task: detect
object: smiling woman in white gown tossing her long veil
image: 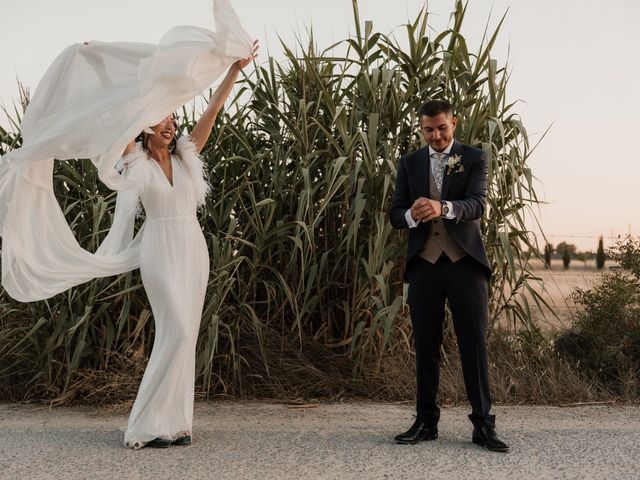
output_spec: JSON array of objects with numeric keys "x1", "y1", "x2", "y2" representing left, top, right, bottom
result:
[{"x1": 0, "y1": 0, "x2": 259, "y2": 449}]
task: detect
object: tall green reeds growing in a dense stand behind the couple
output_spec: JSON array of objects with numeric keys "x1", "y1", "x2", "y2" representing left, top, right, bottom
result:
[{"x1": 0, "y1": 0, "x2": 544, "y2": 404}]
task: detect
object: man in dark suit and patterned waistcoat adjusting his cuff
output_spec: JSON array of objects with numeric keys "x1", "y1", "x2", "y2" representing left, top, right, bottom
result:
[{"x1": 389, "y1": 100, "x2": 509, "y2": 452}]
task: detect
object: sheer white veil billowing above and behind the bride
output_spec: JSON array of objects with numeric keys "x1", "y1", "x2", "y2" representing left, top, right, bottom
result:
[{"x1": 0, "y1": 0, "x2": 252, "y2": 301}]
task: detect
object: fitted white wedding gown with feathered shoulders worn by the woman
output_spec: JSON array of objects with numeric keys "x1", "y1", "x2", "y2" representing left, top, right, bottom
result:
[{"x1": 120, "y1": 137, "x2": 209, "y2": 448}]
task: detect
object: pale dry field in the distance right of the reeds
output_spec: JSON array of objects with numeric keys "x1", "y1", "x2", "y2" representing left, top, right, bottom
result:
[{"x1": 516, "y1": 259, "x2": 614, "y2": 331}]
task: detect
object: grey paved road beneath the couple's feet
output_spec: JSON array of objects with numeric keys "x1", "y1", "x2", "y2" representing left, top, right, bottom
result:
[{"x1": 0, "y1": 402, "x2": 640, "y2": 480}]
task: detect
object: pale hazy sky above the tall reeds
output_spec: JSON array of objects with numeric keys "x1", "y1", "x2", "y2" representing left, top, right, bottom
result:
[{"x1": 0, "y1": 0, "x2": 640, "y2": 250}]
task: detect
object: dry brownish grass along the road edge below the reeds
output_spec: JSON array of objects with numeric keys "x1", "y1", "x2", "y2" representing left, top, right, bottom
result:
[{"x1": 43, "y1": 321, "x2": 610, "y2": 413}]
